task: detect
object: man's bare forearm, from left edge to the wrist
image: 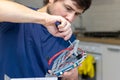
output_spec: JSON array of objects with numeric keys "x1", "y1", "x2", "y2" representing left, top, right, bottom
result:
[{"x1": 0, "y1": 0, "x2": 44, "y2": 23}]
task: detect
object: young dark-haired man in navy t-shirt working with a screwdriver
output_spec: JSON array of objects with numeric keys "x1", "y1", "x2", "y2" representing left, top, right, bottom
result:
[{"x1": 0, "y1": 0, "x2": 91, "y2": 80}]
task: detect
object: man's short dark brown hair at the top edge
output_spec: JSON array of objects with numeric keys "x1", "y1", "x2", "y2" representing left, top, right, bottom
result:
[{"x1": 44, "y1": 0, "x2": 92, "y2": 11}]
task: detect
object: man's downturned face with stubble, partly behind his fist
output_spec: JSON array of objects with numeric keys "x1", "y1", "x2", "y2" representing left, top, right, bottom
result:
[{"x1": 47, "y1": 0, "x2": 83, "y2": 22}]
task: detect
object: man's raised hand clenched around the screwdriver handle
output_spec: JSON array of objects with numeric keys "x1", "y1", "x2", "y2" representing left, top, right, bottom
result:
[{"x1": 43, "y1": 13, "x2": 72, "y2": 40}]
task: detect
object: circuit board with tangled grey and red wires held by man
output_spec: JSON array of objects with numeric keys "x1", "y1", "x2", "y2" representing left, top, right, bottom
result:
[{"x1": 47, "y1": 40, "x2": 87, "y2": 77}]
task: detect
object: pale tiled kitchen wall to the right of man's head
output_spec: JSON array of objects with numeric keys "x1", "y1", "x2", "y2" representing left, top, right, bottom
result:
[{"x1": 82, "y1": 0, "x2": 120, "y2": 31}]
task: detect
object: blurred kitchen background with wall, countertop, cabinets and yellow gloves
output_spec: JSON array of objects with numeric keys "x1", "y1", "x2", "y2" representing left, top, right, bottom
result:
[{"x1": 14, "y1": 0, "x2": 120, "y2": 80}]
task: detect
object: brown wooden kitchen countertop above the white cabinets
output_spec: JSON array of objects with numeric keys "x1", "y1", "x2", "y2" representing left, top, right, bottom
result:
[{"x1": 77, "y1": 37, "x2": 120, "y2": 45}]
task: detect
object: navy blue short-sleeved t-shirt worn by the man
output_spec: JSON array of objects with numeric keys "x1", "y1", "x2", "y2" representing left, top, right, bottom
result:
[{"x1": 0, "y1": 22, "x2": 75, "y2": 80}]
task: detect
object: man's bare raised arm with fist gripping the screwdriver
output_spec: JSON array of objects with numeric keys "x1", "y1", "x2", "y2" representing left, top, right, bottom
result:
[{"x1": 0, "y1": 0, "x2": 72, "y2": 40}]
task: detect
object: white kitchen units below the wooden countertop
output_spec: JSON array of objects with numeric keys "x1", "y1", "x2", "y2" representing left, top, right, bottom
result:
[{"x1": 80, "y1": 42, "x2": 120, "y2": 80}]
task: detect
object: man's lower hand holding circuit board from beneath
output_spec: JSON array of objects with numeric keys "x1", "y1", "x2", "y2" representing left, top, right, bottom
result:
[{"x1": 62, "y1": 68, "x2": 79, "y2": 80}]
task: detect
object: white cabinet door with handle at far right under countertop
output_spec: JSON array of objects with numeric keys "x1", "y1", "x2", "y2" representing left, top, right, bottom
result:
[{"x1": 103, "y1": 45, "x2": 120, "y2": 80}]
